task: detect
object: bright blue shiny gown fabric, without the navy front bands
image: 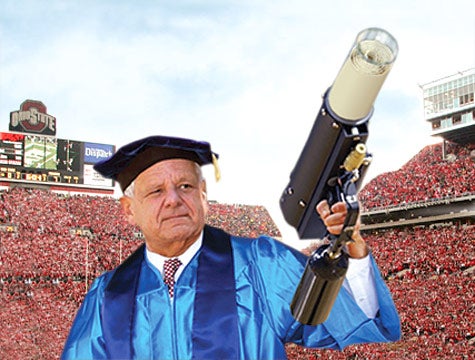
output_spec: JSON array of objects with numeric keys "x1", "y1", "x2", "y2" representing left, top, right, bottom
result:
[{"x1": 62, "y1": 232, "x2": 400, "y2": 359}]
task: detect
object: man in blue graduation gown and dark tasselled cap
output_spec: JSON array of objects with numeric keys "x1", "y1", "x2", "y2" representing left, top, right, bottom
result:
[{"x1": 62, "y1": 136, "x2": 400, "y2": 359}]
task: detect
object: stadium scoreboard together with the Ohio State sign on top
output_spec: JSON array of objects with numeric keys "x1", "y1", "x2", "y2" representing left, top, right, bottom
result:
[{"x1": 0, "y1": 100, "x2": 115, "y2": 192}]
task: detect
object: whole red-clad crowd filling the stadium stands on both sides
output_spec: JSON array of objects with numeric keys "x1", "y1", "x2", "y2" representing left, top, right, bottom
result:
[{"x1": 0, "y1": 145, "x2": 475, "y2": 359}]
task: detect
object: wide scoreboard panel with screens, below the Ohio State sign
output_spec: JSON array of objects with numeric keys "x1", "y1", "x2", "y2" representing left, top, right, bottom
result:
[{"x1": 0, "y1": 132, "x2": 115, "y2": 189}]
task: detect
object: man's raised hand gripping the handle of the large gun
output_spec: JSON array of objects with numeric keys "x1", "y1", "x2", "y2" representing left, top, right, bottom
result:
[{"x1": 316, "y1": 200, "x2": 369, "y2": 259}]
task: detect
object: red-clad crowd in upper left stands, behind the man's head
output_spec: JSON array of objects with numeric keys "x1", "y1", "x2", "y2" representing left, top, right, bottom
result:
[{"x1": 0, "y1": 188, "x2": 280, "y2": 279}]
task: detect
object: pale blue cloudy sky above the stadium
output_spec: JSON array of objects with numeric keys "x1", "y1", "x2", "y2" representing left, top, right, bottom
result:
[{"x1": 0, "y1": 0, "x2": 475, "y2": 247}]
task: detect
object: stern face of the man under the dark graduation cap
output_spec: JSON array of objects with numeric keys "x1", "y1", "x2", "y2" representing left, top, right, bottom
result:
[{"x1": 121, "y1": 159, "x2": 208, "y2": 256}]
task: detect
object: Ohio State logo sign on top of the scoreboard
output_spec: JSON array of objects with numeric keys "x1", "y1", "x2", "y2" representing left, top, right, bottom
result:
[{"x1": 9, "y1": 100, "x2": 56, "y2": 136}]
